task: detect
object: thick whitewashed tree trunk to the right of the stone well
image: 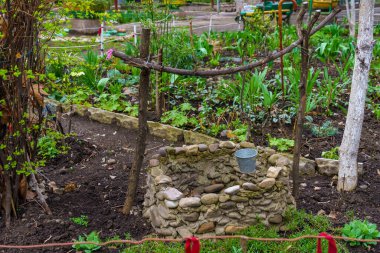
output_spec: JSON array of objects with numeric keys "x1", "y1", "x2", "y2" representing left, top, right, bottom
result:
[{"x1": 338, "y1": 0, "x2": 375, "y2": 191}]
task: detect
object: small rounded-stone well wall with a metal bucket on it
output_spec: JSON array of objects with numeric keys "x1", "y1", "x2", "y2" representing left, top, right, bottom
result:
[{"x1": 144, "y1": 141, "x2": 294, "y2": 237}]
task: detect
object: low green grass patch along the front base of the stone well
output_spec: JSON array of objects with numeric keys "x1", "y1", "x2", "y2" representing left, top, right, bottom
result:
[{"x1": 122, "y1": 209, "x2": 349, "y2": 253}]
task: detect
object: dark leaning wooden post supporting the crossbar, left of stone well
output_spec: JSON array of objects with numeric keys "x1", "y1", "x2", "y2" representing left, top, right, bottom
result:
[{"x1": 123, "y1": 28, "x2": 150, "y2": 214}]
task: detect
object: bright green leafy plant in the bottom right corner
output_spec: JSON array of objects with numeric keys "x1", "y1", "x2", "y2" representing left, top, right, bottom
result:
[{"x1": 342, "y1": 220, "x2": 380, "y2": 247}]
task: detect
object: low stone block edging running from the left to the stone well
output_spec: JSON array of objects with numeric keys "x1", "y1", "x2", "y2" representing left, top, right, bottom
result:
[{"x1": 47, "y1": 99, "x2": 219, "y2": 144}]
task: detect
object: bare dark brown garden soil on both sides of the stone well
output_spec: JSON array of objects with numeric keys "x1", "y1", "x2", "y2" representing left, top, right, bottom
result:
[{"x1": 0, "y1": 114, "x2": 380, "y2": 252}]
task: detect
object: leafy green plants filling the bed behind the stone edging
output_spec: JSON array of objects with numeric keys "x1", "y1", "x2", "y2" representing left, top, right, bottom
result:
[{"x1": 47, "y1": 24, "x2": 380, "y2": 144}]
